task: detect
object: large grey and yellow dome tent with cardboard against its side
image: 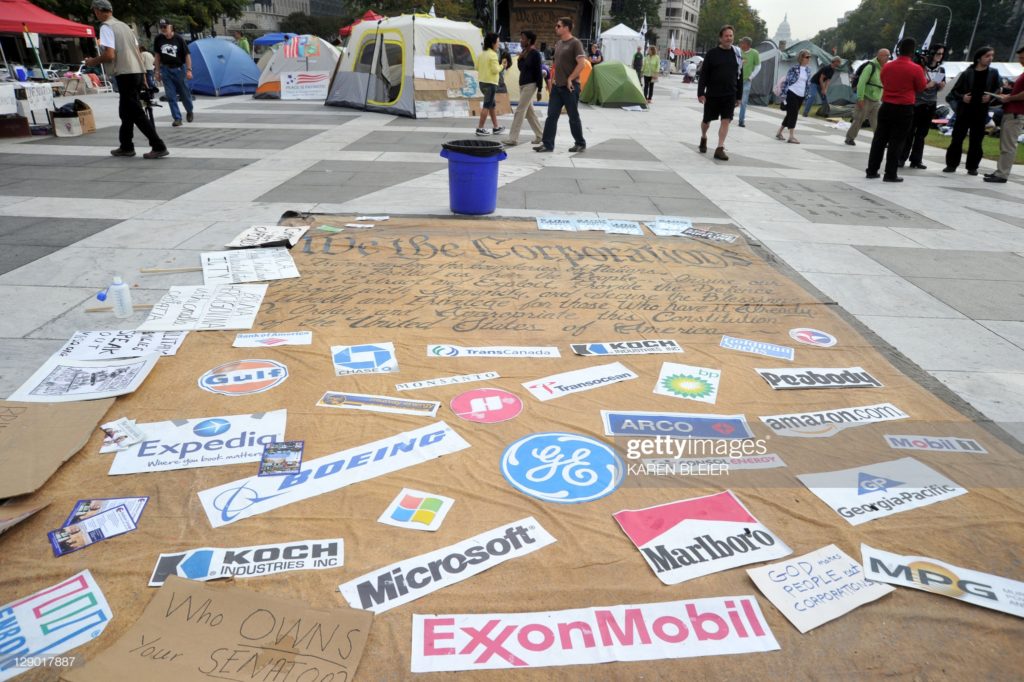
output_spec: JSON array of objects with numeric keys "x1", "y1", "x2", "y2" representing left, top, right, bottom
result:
[{"x1": 326, "y1": 14, "x2": 483, "y2": 118}]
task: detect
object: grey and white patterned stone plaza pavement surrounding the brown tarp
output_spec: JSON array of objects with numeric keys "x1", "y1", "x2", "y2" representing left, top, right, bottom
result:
[{"x1": 0, "y1": 82, "x2": 1024, "y2": 439}]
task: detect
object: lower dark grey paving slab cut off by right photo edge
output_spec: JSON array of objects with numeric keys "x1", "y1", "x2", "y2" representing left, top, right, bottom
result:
[{"x1": 854, "y1": 246, "x2": 1024, "y2": 282}]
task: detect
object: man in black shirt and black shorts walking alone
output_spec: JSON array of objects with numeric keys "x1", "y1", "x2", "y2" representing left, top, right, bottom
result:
[{"x1": 697, "y1": 26, "x2": 743, "y2": 161}]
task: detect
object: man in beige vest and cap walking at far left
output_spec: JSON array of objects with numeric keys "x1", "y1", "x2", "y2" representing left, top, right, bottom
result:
[{"x1": 85, "y1": 0, "x2": 170, "y2": 159}]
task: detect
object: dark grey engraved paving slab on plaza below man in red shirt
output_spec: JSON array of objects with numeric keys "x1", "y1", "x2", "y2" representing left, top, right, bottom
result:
[{"x1": 740, "y1": 176, "x2": 950, "y2": 229}]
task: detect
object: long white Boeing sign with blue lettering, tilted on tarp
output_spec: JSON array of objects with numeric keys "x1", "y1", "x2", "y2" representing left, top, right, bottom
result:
[{"x1": 199, "y1": 422, "x2": 469, "y2": 528}]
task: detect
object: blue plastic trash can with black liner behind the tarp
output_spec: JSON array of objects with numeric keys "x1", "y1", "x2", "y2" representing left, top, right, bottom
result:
[{"x1": 441, "y1": 139, "x2": 508, "y2": 215}]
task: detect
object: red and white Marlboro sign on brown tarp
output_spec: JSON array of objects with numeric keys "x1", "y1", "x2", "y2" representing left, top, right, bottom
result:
[{"x1": 612, "y1": 491, "x2": 793, "y2": 585}]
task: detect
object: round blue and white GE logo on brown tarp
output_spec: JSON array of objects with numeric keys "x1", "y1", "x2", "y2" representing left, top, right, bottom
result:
[{"x1": 502, "y1": 433, "x2": 626, "y2": 504}]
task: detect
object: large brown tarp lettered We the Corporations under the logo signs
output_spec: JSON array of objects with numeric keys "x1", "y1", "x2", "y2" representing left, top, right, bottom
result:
[{"x1": 0, "y1": 215, "x2": 1024, "y2": 682}]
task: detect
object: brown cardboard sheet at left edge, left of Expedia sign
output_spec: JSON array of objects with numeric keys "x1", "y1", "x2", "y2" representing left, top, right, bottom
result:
[{"x1": 0, "y1": 398, "x2": 114, "y2": 499}]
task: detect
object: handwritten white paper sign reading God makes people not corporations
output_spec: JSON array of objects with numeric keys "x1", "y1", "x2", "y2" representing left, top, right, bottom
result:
[{"x1": 746, "y1": 545, "x2": 895, "y2": 632}]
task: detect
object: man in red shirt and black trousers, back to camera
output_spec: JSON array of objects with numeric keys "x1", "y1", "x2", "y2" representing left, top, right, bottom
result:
[{"x1": 866, "y1": 38, "x2": 928, "y2": 182}]
